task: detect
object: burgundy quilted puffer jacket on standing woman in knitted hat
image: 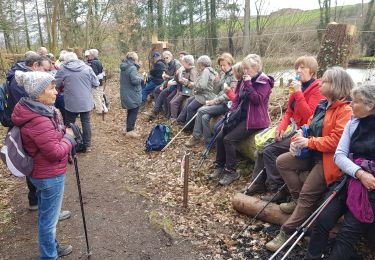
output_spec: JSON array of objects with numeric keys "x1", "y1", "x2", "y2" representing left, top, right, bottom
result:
[{"x1": 12, "y1": 103, "x2": 72, "y2": 179}]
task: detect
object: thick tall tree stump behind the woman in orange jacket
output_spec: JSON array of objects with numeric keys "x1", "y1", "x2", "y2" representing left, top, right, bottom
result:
[{"x1": 318, "y1": 23, "x2": 357, "y2": 78}]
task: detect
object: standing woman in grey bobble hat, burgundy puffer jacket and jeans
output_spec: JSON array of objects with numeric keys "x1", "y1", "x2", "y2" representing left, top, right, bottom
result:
[{"x1": 12, "y1": 71, "x2": 75, "y2": 259}]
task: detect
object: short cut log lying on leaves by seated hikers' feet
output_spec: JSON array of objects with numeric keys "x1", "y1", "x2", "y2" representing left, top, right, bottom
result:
[{"x1": 232, "y1": 193, "x2": 290, "y2": 225}]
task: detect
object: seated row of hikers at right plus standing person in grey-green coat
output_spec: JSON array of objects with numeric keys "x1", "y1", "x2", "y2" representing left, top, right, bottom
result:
[{"x1": 120, "y1": 51, "x2": 375, "y2": 260}]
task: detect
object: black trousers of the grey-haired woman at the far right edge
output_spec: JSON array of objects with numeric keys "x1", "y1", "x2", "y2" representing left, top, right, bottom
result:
[{"x1": 305, "y1": 186, "x2": 375, "y2": 260}]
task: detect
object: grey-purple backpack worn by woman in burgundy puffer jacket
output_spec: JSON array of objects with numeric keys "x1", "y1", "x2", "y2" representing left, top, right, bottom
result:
[{"x1": 0, "y1": 126, "x2": 33, "y2": 177}]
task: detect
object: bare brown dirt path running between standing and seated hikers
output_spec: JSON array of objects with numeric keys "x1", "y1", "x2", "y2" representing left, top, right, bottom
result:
[{"x1": 0, "y1": 78, "x2": 203, "y2": 259}]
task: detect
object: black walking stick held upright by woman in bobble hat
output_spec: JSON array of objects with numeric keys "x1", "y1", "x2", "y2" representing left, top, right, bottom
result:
[{"x1": 70, "y1": 123, "x2": 91, "y2": 258}]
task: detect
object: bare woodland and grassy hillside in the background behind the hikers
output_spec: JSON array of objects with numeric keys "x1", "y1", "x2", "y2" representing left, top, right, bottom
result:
[{"x1": 0, "y1": 0, "x2": 375, "y2": 76}]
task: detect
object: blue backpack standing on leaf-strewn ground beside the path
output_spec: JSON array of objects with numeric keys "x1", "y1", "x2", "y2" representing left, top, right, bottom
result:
[{"x1": 145, "y1": 124, "x2": 171, "y2": 152}]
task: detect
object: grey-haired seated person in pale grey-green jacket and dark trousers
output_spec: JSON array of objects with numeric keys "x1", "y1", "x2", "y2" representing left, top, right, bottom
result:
[{"x1": 177, "y1": 55, "x2": 218, "y2": 130}]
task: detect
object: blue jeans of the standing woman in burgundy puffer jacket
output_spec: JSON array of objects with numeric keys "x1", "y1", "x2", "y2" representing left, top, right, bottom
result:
[{"x1": 30, "y1": 174, "x2": 65, "y2": 260}]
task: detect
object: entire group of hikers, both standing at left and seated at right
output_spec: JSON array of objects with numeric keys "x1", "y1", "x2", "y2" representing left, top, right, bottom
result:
[{"x1": 2, "y1": 47, "x2": 375, "y2": 259}]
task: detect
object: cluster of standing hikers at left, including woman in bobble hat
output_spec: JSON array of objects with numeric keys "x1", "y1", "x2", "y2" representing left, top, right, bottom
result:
[{"x1": 2, "y1": 47, "x2": 108, "y2": 259}]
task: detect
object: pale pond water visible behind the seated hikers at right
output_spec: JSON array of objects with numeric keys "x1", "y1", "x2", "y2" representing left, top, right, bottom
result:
[{"x1": 269, "y1": 67, "x2": 375, "y2": 85}]
